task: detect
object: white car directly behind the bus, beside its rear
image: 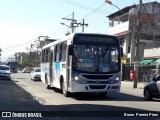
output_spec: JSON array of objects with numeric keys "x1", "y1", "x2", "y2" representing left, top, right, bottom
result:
[{"x1": 30, "y1": 67, "x2": 41, "y2": 80}]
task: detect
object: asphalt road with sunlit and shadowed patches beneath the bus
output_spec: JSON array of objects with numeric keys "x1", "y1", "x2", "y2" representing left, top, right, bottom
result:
[{"x1": 0, "y1": 73, "x2": 160, "y2": 120}]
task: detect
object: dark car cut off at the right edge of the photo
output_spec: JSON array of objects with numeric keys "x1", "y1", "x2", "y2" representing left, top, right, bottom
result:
[{"x1": 143, "y1": 75, "x2": 160, "y2": 100}]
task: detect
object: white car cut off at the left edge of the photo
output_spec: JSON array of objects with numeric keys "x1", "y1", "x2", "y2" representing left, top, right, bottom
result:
[{"x1": 0, "y1": 65, "x2": 11, "y2": 80}]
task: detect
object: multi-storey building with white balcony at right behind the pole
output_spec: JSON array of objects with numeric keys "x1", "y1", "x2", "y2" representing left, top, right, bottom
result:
[{"x1": 107, "y1": 2, "x2": 160, "y2": 63}]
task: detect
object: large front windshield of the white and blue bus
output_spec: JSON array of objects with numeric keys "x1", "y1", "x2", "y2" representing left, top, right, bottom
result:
[{"x1": 73, "y1": 45, "x2": 120, "y2": 73}]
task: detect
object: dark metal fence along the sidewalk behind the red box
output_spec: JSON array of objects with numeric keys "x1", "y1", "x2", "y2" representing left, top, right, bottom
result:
[{"x1": 122, "y1": 63, "x2": 157, "y2": 81}]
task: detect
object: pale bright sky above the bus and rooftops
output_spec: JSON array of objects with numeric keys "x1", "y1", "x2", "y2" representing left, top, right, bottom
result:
[{"x1": 0, "y1": 0, "x2": 160, "y2": 61}]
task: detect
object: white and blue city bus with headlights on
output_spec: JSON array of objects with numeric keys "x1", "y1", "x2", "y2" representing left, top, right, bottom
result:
[{"x1": 41, "y1": 33, "x2": 123, "y2": 96}]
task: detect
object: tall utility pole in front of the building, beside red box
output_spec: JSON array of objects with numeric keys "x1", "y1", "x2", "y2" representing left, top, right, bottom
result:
[{"x1": 133, "y1": 0, "x2": 142, "y2": 88}]
